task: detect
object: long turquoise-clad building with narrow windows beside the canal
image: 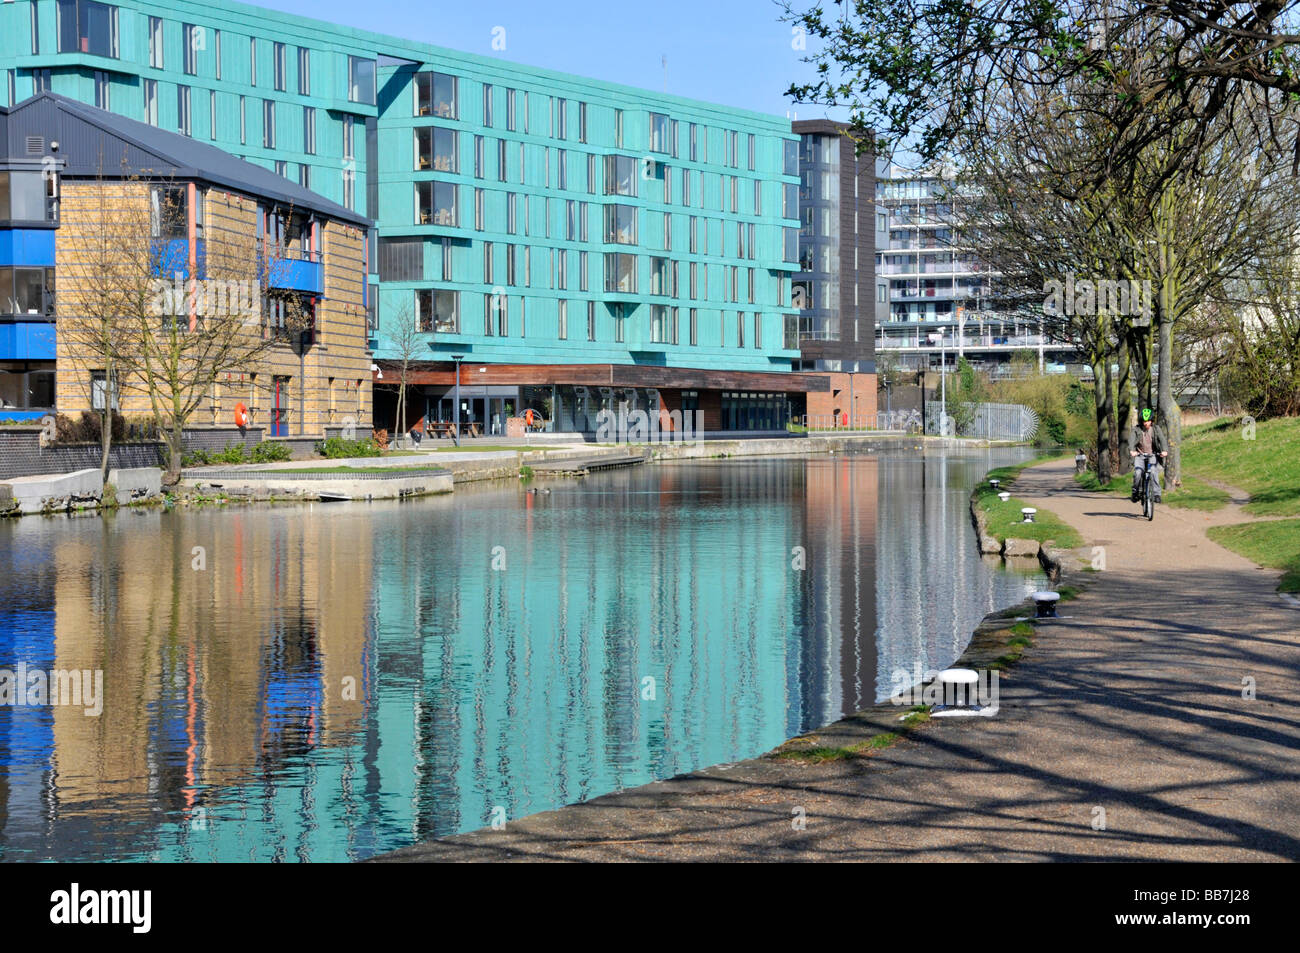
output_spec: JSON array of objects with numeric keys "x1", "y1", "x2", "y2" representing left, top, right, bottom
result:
[{"x1": 0, "y1": 0, "x2": 828, "y2": 433}]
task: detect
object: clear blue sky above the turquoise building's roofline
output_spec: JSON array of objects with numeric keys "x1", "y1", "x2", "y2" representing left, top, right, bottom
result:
[{"x1": 246, "y1": 0, "x2": 845, "y2": 120}]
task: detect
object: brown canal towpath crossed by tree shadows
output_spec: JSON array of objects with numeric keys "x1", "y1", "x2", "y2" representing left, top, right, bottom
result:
[{"x1": 374, "y1": 462, "x2": 1300, "y2": 861}]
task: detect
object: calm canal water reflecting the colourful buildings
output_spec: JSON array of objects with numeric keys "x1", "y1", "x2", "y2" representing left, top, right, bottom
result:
[{"x1": 0, "y1": 449, "x2": 1041, "y2": 861}]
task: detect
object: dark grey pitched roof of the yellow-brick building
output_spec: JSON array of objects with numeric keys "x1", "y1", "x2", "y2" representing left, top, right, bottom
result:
[{"x1": 0, "y1": 92, "x2": 373, "y2": 228}]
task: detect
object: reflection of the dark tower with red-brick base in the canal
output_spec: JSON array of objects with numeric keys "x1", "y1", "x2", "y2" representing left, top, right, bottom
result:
[{"x1": 790, "y1": 455, "x2": 878, "y2": 735}]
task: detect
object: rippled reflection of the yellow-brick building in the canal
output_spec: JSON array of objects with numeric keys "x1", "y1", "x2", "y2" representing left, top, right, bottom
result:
[{"x1": 0, "y1": 508, "x2": 371, "y2": 855}]
